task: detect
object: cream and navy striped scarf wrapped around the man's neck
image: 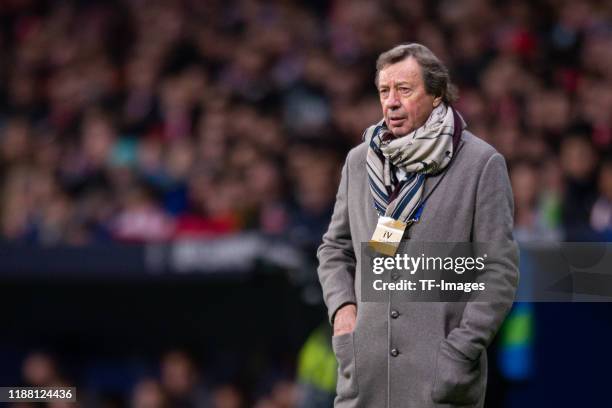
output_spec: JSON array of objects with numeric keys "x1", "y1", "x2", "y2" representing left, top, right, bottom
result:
[{"x1": 364, "y1": 104, "x2": 465, "y2": 223}]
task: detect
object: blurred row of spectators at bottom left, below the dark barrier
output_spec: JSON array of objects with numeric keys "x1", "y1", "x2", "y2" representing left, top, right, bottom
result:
[{"x1": 10, "y1": 350, "x2": 303, "y2": 408}]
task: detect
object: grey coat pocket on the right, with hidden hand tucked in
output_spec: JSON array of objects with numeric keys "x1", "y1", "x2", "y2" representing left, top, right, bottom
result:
[{"x1": 431, "y1": 340, "x2": 484, "y2": 405}]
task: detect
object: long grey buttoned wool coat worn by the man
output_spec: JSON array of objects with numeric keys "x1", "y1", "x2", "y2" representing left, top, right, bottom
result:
[{"x1": 317, "y1": 130, "x2": 518, "y2": 408}]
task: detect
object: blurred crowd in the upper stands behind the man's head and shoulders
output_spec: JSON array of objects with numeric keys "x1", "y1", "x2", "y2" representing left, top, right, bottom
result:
[{"x1": 0, "y1": 0, "x2": 612, "y2": 245}]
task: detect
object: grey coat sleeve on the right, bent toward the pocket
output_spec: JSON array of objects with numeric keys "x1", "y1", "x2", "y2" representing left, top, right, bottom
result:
[{"x1": 446, "y1": 153, "x2": 519, "y2": 360}]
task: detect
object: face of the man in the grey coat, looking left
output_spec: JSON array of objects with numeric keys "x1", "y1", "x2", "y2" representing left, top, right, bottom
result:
[{"x1": 378, "y1": 57, "x2": 440, "y2": 137}]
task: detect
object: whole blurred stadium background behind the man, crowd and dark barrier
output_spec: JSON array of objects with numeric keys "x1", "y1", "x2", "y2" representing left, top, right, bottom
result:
[{"x1": 0, "y1": 0, "x2": 612, "y2": 408}]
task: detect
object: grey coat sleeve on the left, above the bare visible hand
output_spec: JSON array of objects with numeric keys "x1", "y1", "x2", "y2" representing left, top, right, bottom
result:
[{"x1": 317, "y1": 158, "x2": 357, "y2": 324}]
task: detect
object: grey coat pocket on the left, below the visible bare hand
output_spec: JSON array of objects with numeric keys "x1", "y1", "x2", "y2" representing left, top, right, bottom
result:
[{"x1": 332, "y1": 332, "x2": 358, "y2": 398}]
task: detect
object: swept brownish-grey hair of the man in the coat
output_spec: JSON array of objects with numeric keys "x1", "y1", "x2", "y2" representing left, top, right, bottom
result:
[{"x1": 374, "y1": 43, "x2": 458, "y2": 103}]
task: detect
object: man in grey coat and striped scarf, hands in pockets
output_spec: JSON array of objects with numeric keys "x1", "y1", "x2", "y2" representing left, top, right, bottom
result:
[{"x1": 318, "y1": 44, "x2": 518, "y2": 408}]
